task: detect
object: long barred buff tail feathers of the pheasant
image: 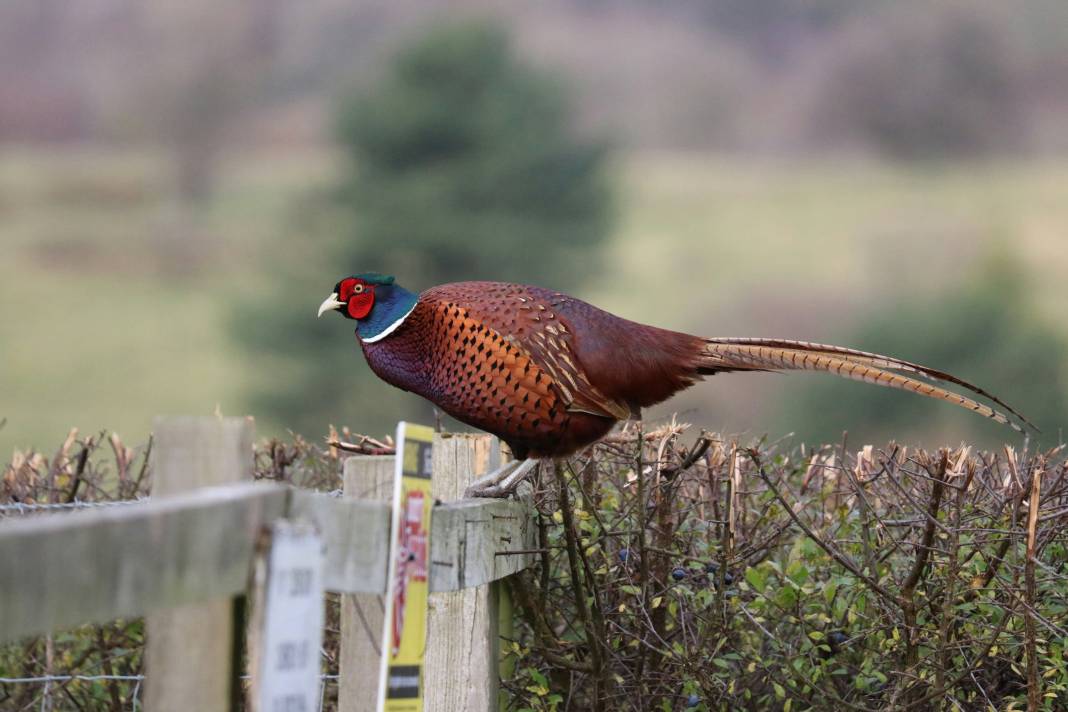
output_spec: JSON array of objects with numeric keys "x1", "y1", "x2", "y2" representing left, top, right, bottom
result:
[{"x1": 701, "y1": 337, "x2": 1037, "y2": 432}]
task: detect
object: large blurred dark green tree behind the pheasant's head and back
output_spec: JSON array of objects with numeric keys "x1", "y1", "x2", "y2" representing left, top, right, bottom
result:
[{"x1": 239, "y1": 22, "x2": 609, "y2": 432}]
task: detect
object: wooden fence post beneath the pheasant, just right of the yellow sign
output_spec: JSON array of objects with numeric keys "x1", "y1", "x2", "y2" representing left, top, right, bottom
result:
[{"x1": 424, "y1": 433, "x2": 500, "y2": 712}]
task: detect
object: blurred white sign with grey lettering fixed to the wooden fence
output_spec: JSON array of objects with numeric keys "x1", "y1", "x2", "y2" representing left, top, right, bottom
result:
[{"x1": 252, "y1": 522, "x2": 324, "y2": 712}]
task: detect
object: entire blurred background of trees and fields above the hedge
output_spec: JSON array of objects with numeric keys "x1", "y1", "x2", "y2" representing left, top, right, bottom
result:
[{"x1": 0, "y1": 0, "x2": 1068, "y2": 450}]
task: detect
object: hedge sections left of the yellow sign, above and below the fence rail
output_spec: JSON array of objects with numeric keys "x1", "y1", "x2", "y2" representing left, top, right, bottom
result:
[{"x1": 0, "y1": 431, "x2": 358, "y2": 712}]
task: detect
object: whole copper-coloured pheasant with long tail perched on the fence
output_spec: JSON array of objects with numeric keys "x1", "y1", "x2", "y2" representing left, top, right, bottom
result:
[{"x1": 318, "y1": 272, "x2": 1034, "y2": 493}]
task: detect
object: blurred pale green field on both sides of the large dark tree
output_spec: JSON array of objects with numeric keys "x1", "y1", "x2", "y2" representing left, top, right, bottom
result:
[{"x1": 0, "y1": 148, "x2": 1068, "y2": 457}]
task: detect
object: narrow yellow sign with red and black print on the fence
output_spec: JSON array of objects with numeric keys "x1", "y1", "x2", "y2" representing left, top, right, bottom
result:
[{"x1": 378, "y1": 422, "x2": 434, "y2": 712}]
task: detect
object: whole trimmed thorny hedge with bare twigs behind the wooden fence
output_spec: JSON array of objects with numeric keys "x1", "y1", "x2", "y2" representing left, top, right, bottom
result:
[{"x1": 0, "y1": 424, "x2": 1068, "y2": 711}]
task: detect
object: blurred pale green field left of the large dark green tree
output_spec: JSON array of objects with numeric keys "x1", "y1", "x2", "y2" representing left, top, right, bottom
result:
[{"x1": 0, "y1": 152, "x2": 331, "y2": 453}]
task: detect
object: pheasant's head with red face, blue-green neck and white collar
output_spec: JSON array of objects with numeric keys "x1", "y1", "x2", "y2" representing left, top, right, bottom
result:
[{"x1": 319, "y1": 272, "x2": 419, "y2": 342}]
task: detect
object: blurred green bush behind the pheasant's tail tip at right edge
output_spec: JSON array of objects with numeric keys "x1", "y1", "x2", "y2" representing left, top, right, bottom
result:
[{"x1": 780, "y1": 252, "x2": 1068, "y2": 446}]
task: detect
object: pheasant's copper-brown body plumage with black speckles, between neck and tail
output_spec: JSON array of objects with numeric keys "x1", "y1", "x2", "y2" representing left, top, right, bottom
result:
[{"x1": 358, "y1": 282, "x2": 700, "y2": 457}]
